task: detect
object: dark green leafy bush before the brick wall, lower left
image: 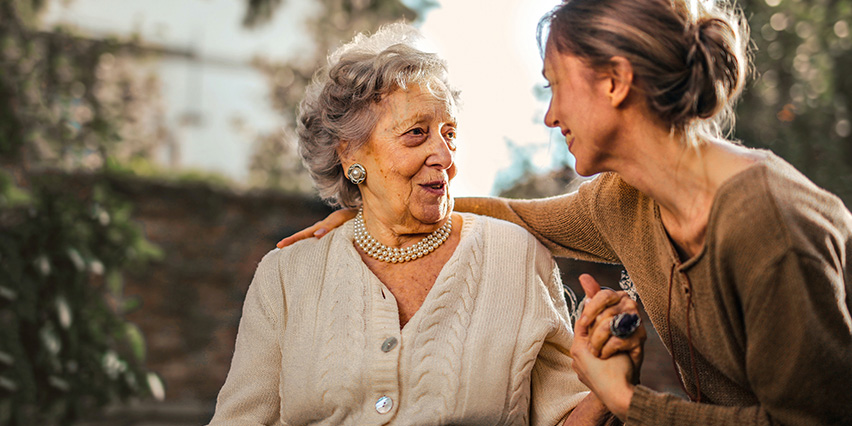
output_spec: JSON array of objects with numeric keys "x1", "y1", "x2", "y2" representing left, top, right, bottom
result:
[{"x1": 0, "y1": 171, "x2": 158, "y2": 425}]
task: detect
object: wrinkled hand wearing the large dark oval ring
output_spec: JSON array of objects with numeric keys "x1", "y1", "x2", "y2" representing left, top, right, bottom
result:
[{"x1": 574, "y1": 274, "x2": 647, "y2": 383}]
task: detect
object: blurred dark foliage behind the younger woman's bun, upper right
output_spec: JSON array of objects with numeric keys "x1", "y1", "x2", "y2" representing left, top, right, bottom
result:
[{"x1": 736, "y1": 0, "x2": 852, "y2": 206}]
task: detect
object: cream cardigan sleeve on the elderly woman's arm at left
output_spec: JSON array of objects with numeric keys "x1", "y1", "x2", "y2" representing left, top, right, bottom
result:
[{"x1": 209, "y1": 251, "x2": 281, "y2": 426}]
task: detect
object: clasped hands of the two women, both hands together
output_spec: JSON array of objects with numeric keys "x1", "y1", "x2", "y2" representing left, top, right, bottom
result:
[{"x1": 571, "y1": 274, "x2": 646, "y2": 420}]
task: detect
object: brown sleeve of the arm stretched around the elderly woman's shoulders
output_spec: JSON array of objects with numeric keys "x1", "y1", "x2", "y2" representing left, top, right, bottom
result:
[{"x1": 455, "y1": 174, "x2": 619, "y2": 263}]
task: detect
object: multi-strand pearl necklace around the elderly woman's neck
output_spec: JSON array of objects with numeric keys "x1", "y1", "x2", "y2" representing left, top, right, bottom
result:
[{"x1": 355, "y1": 209, "x2": 453, "y2": 263}]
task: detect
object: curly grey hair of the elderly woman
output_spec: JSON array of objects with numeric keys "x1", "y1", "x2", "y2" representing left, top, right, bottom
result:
[{"x1": 297, "y1": 23, "x2": 459, "y2": 207}]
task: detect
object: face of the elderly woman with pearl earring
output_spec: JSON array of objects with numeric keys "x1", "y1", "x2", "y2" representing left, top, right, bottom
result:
[{"x1": 354, "y1": 85, "x2": 456, "y2": 230}]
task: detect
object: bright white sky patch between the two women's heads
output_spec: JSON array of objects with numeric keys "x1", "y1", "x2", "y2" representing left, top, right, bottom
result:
[{"x1": 421, "y1": 0, "x2": 564, "y2": 196}]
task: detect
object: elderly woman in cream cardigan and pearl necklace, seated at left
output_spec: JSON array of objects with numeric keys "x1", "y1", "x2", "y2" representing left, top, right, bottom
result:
[{"x1": 210, "y1": 24, "x2": 620, "y2": 425}]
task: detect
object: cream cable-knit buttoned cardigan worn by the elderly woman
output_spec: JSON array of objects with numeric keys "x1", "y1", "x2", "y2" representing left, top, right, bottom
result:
[{"x1": 210, "y1": 214, "x2": 587, "y2": 426}]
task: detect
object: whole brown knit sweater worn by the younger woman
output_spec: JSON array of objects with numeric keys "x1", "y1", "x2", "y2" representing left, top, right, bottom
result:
[{"x1": 456, "y1": 153, "x2": 852, "y2": 425}]
